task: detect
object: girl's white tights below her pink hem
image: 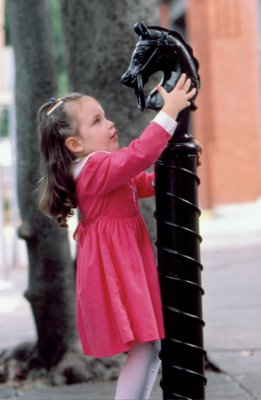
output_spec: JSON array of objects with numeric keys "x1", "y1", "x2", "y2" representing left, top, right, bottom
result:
[{"x1": 115, "y1": 341, "x2": 160, "y2": 400}]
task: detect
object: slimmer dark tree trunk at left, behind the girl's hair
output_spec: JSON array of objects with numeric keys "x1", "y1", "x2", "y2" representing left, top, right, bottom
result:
[{"x1": 7, "y1": 0, "x2": 76, "y2": 369}]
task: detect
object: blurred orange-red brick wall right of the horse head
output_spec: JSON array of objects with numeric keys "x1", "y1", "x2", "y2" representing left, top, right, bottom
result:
[{"x1": 187, "y1": 0, "x2": 261, "y2": 208}]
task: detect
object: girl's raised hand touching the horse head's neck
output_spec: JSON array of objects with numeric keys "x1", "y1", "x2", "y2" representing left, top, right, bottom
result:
[{"x1": 157, "y1": 74, "x2": 197, "y2": 119}]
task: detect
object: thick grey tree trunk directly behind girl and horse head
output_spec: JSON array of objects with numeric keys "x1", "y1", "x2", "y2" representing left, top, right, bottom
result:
[{"x1": 60, "y1": 0, "x2": 159, "y2": 237}]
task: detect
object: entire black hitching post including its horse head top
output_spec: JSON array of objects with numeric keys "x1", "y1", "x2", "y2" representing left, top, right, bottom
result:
[{"x1": 121, "y1": 22, "x2": 206, "y2": 400}]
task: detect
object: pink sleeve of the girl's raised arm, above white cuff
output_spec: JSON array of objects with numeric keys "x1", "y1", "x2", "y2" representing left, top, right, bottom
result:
[{"x1": 76, "y1": 120, "x2": 172, "y2": 196}]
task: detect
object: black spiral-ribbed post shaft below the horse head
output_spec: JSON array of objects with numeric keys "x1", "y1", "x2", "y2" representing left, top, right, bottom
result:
[{"x1": 155, "y1": 109, "x2": 206, "y2": 400}]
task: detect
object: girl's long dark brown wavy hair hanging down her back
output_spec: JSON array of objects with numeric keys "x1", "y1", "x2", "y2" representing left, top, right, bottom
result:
[{"x1": 37, "y1": 93, "x2": 83, "y2": 227}]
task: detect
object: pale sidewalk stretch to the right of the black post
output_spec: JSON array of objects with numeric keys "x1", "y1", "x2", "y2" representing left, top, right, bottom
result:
[{"x1": 201, "y1": 202, "x2": 261, "y2": 400}]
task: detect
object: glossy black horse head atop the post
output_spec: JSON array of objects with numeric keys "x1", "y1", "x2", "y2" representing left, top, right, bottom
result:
[{"x1": 121, "y1": 22, "x2": 200, "y2": 111}]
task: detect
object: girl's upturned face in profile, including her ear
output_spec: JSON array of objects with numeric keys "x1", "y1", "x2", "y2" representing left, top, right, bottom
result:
[{"x1": 65, "y1": 96, "x2": 119, "y2": 157}]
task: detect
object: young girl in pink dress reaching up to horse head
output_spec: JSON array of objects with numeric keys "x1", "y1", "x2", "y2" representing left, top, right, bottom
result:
[{"x1": 38, "y1": 74, "x2": 195, "y2": 400}]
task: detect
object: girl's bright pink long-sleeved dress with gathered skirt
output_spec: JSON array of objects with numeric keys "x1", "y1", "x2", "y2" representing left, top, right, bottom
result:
[{"x1": 75, "y1": 122, "x2": 170, "y2": 357}]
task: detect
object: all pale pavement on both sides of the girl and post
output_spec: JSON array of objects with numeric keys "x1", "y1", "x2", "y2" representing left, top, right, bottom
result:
[{"x1": 0, "y1": 200, "x2": 261, "y2": 400}]
